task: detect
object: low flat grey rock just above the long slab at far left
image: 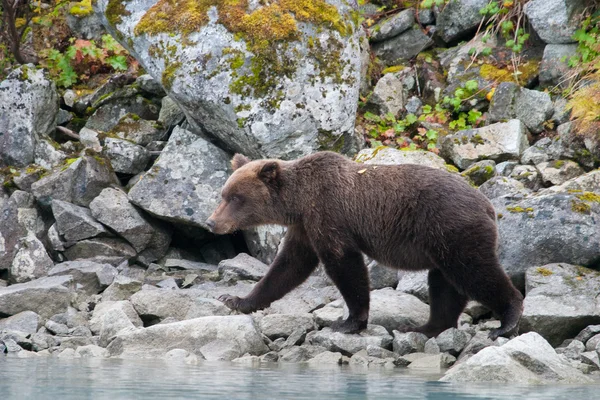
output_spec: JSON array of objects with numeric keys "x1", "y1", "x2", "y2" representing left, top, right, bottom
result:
[{"x1": 48, "y1": 261, "x2": 118, "y2": 295}]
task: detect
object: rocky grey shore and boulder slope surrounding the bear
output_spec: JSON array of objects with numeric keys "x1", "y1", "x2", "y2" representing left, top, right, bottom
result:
[{"x1": 0, "y1": 0, "x2": 600, "y2": 383}]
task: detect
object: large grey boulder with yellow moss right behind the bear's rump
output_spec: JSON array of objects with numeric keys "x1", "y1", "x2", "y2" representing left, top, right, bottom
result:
[{"x1": 494, "y1": 191, "x2": 600, "y2": 287}]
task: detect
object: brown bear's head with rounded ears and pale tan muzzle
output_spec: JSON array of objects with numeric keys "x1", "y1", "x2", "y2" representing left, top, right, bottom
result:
[{"x1": 206, "y1": 154, "x2": 281, "y2": 235}]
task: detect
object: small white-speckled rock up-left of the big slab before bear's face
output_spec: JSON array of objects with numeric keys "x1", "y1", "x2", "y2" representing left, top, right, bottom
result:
[{"x1": 104, "y1": 138, "x2": 150, "y2": 175}]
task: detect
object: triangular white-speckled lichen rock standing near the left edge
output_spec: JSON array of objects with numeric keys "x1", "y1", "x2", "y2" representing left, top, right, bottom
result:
[{"x1": 9, "y1": 232, "x2": 54, "y2": 283}]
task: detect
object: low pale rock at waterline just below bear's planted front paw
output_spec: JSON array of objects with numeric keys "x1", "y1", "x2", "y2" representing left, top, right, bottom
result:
[{"x1": 306, "y1": 325, "x2": 393, "y2": 355}]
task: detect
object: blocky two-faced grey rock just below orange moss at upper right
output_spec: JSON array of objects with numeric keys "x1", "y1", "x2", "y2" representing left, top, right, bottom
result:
[{"x1": 488, "y1": 82, "x2": 554, "y2": 133}]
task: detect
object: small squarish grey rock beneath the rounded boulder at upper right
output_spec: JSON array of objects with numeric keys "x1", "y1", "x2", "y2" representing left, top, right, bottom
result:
[{"x1": 540, "y1": 44, "x2": 577, "y2": 89}]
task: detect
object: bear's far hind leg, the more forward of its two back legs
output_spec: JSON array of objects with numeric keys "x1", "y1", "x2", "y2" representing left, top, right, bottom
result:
[{"x1": 402, "y1": 269, "x2": 468, "y2": 337}]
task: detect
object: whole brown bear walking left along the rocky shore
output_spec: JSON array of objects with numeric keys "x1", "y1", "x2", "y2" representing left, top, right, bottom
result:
[{"x1": 206, "y1": 152, "x2": 523, "y2": 339}]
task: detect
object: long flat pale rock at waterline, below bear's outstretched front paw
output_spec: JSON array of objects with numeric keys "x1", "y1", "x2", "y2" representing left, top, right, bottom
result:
[{"x1": 107, "y1": 315, "x2": 269, "y2": 360}]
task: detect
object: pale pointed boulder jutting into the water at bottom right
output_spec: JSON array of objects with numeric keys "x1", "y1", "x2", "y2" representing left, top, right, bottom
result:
[{"x1": 440, "y1": 332, "x2": 592, "y2": 384}]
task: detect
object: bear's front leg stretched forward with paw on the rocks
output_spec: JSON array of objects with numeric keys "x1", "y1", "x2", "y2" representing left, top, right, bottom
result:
[{"x1": 219, "y1": 225, "x2": 319, "y2": 314}]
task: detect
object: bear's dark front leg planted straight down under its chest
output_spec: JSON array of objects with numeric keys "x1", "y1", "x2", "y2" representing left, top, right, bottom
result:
[{"x1": 321, "y1": 252, "x2": 369, "y2": 333}]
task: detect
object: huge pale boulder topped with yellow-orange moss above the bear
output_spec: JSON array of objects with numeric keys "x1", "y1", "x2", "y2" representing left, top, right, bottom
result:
[{"x1": 94, "y1": 0, "x2": 363, "y2": 158}]
